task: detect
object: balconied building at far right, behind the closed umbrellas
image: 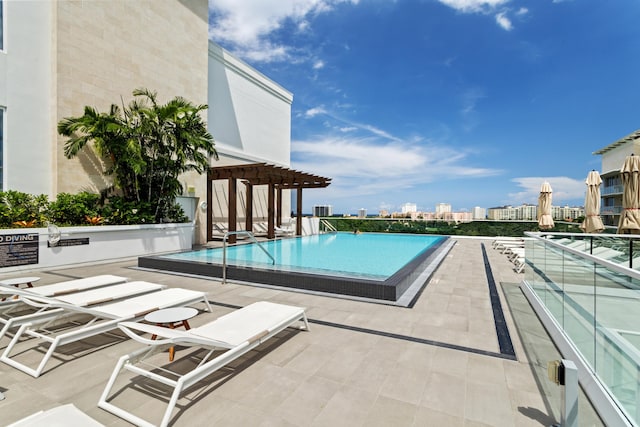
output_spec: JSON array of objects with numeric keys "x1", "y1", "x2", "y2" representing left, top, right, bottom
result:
[{"x1": 593, "y1": 130, "x2": 640, "y2": 226}]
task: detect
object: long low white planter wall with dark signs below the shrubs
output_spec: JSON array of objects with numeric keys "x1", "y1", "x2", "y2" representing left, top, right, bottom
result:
[{"x1": 0, "y1": 223, "x2": 194, "y2": 274}]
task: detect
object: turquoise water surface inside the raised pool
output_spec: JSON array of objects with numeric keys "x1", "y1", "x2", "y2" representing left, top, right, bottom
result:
[{"x1": 163, "y1": 233, "x2": 443, "y2": 280}]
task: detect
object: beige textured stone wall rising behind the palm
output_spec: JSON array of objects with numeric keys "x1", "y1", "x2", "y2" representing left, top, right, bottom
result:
[{"x1": 52, "y1": 0, "x2": 208, "y2": 193}]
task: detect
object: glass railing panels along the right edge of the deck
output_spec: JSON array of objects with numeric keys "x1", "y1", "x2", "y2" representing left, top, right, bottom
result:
[{"x1": 523, "y1": 233, "x2": 640, "y2": 425}]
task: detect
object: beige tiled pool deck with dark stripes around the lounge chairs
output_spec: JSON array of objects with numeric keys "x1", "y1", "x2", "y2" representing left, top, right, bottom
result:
[{"x1": 0, "y1": 238, "x2": 603, "y2": 427}]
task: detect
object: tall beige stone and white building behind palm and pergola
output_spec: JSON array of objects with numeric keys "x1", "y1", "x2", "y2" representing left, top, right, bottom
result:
[{"x1": 0, "y1": 0, "x2": 293, "y2": 243}]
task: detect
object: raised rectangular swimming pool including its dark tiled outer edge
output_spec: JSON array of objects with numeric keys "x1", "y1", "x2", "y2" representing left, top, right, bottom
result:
[{"x1": 138, "y1": 233, "x2": 448, "y2": 301}]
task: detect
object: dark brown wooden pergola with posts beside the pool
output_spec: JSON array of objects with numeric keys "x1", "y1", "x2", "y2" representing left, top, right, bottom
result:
[{"x1": 207, "y1": 163, "x2": 331, "y2": 243}]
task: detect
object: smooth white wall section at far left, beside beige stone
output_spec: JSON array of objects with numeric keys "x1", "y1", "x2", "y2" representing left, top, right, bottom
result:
[{"x1": 0, "y1": 1, "x2": 54, "y2": 196}]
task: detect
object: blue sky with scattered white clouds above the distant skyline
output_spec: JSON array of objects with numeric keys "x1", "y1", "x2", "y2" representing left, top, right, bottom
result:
[{"x1": 209, "y1": 0, "x2": 640, "y2": 214}]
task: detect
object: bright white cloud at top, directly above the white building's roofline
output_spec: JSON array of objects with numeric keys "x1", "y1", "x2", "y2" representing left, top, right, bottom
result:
[{"x1": 209, "y1": 0, "x2": 358, "y2": 62}]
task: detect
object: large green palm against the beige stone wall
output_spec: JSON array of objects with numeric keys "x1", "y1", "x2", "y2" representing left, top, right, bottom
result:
[{"x1": 58, "y1": 89, "x2": 218, "y2": 222}]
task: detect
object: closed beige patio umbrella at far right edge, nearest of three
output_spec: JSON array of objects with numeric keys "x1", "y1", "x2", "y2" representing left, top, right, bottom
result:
[{"x1": 618, "y1": 154, "x2": 640, "y2": 234}]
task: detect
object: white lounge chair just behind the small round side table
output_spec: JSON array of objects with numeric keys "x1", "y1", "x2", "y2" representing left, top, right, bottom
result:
[{"x1": 0, "y1": 288, "x2": 211, "y2": 377}]
